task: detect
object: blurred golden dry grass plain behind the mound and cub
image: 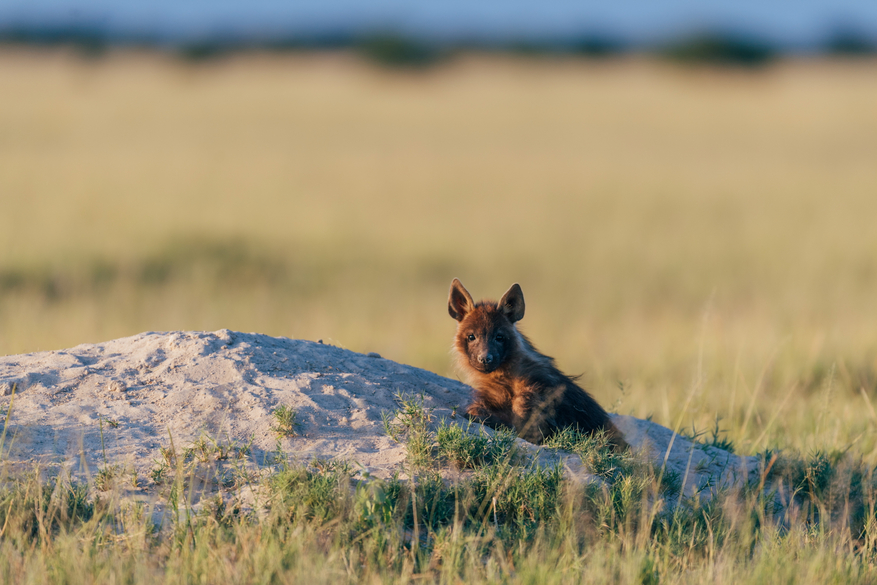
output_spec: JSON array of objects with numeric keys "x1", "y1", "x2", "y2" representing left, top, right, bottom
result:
[{"x1": 0, "y1": 50, "x2": 877, "y2": 456}]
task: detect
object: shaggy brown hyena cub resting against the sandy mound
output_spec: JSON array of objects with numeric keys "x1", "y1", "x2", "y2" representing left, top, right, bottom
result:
[{"x1": 448, "y1": 278, "x2": 627, "y2": 449}]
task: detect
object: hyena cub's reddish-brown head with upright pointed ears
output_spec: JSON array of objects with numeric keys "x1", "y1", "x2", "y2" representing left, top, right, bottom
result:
[{"x1": 448, "y1": 278, "x2": 524, "y2": 374}]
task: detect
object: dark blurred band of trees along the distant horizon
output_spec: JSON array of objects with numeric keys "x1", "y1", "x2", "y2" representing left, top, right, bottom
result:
[{"x1": 0, "y1": 24, "x2": 877, "y2": 67}]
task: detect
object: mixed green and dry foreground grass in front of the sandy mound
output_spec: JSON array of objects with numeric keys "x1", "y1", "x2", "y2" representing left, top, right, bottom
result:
[{"x1": 0, "y1": 410, "x2": 877, "y2": 584}]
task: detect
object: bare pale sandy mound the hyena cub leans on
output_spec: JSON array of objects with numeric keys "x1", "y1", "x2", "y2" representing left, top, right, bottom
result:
[{"x1": 0, "y1": 330, "x2": 757, "y2": 494}]
